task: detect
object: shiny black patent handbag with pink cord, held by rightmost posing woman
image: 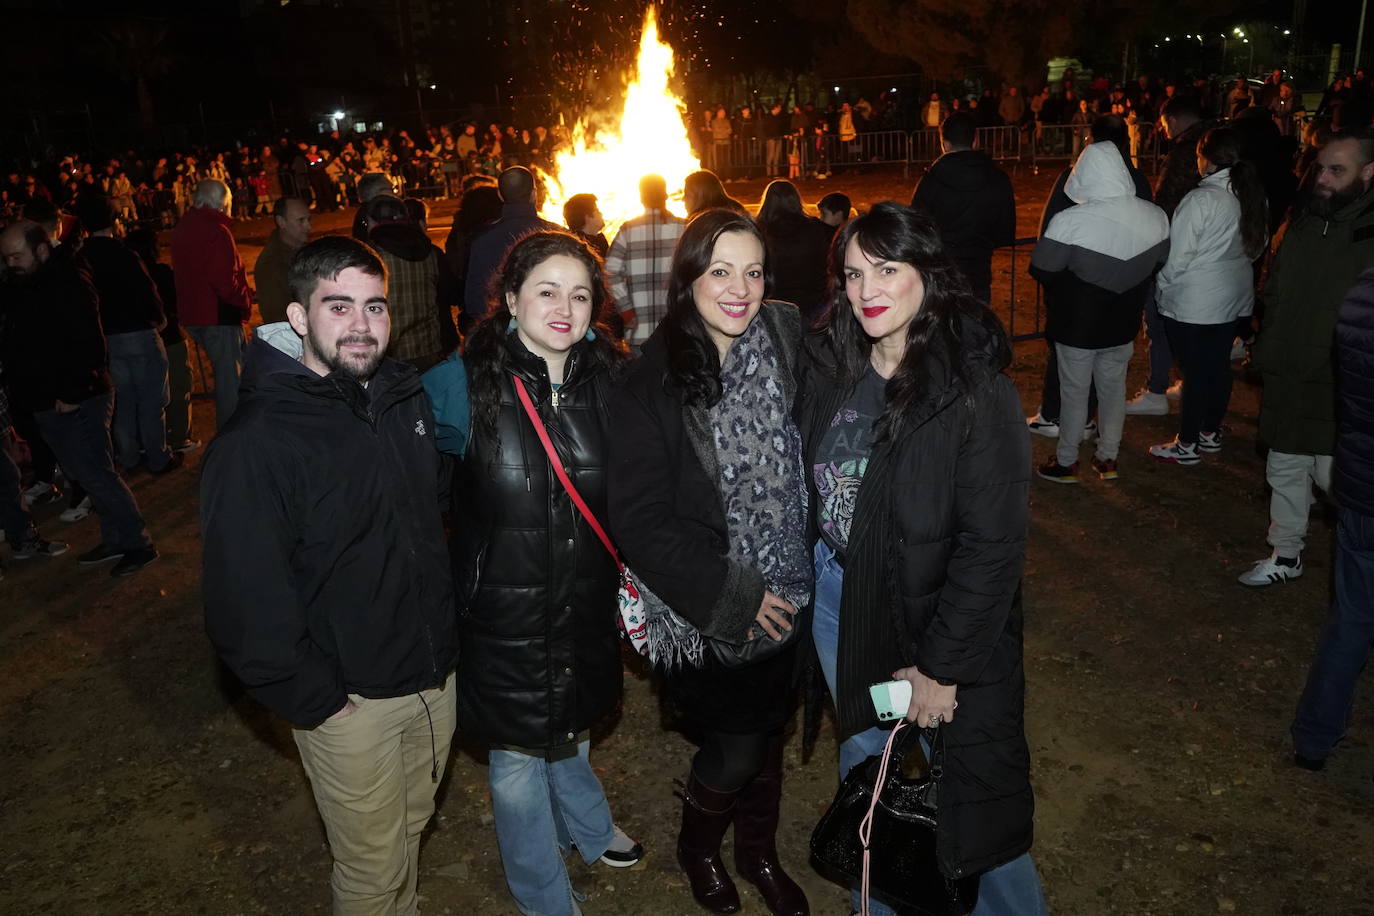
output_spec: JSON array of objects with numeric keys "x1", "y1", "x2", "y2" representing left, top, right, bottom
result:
[{"x1": 811, "y1": 722, "x2": 978, "y2": 916}]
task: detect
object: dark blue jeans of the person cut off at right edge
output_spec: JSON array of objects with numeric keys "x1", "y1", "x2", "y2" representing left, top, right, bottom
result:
[{"x1": 1292, "y1": 508, "x2": 1374, "y2": 759}]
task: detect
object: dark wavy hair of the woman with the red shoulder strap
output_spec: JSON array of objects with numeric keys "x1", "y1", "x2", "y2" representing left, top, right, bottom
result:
[{"x1": 463, "y1": 229, "x2": 628, "y2": 435}]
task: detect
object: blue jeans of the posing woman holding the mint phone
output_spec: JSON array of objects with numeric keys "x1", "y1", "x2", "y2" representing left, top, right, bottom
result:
[{"x1": 811, "y1": 540, "x2": 1050, "y2": 916}]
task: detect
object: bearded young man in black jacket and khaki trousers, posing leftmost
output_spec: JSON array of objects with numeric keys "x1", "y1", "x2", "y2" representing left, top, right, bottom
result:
[{"x1": 201, "y1": 236, "x2": 458, "y2": 915}]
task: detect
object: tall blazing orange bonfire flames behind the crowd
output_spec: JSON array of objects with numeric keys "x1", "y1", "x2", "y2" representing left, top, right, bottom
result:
[{"x1": 540, "y1": 5, "x2": 701, "y2": 238}]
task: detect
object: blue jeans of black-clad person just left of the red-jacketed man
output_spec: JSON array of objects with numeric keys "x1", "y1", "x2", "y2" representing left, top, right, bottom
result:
[{"x1": 104, "y1": 328, "x2": 172, "y2": 471}]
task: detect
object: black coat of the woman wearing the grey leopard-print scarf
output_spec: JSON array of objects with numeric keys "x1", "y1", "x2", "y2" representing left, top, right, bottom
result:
[{"x1": 607, "y1": 302, "x2": 809, "y2": 733}]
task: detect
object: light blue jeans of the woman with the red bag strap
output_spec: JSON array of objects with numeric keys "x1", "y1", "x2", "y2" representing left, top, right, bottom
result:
[{"x1": 488, "y1": 740, "x2": 616, "y2": 916}]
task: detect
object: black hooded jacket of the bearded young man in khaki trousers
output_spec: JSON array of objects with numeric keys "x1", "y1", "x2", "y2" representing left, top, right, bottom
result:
[{"x1": 201, "y1": 338, "x2": 458, "y2": 728}]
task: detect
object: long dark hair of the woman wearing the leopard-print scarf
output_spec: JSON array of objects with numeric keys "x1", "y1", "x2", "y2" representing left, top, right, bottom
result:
[{"x1": 661, "y1": 209, "x2": 772, "y2": 407}]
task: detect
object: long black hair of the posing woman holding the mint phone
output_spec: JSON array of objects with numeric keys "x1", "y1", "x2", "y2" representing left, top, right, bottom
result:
[{"x1": 824, "y1": 201, "x2": 1011, "y2": 442}]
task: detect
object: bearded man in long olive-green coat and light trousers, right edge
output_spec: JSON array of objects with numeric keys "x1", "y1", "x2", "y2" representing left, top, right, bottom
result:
[{"x1": 1239, "y1": 128, "x2": 1374, "y2": 586}]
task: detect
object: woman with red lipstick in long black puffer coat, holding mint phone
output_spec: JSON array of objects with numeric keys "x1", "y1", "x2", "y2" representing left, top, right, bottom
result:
[{"x1": 797, "y1": 202, "x2": 1047, "y2": 916}]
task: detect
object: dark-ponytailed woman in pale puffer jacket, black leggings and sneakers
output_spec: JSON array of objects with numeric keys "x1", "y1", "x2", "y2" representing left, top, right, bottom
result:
[{"x1": 1150, "y1": 128, "x2": 1268, "y2": 466}]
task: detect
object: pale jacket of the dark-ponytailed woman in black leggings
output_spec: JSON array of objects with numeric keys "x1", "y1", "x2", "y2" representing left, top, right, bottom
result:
[{"x1": 1156, "y1": 169, "x2": 1254, "y2": 324}]
